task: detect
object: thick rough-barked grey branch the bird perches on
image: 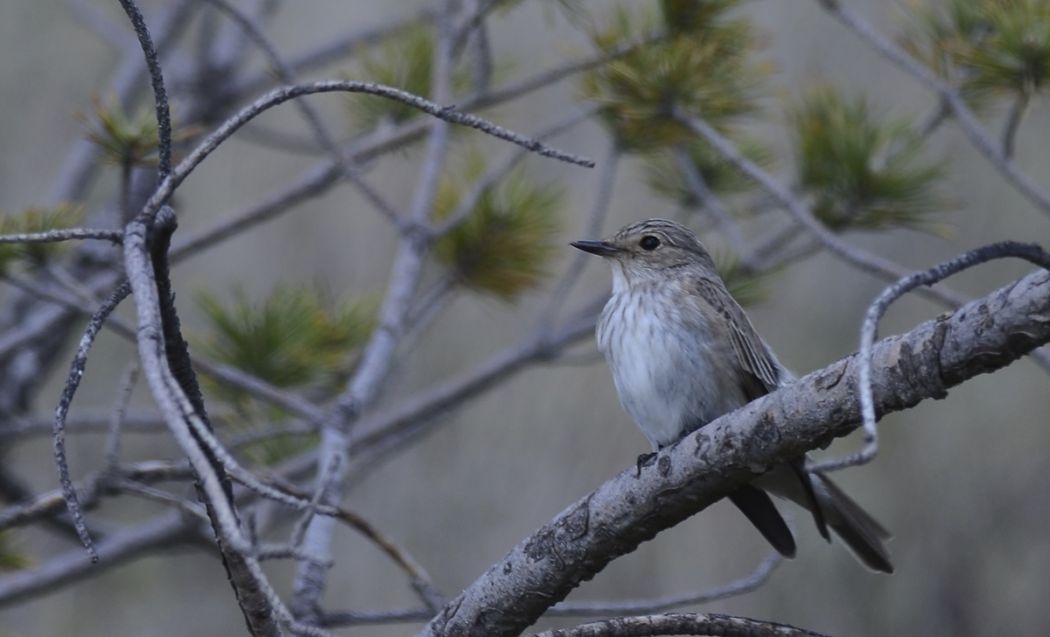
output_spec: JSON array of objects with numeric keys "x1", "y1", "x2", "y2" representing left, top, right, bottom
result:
[{"x1": 420, "y1": 271, "x2": 1050, "y2": 636}]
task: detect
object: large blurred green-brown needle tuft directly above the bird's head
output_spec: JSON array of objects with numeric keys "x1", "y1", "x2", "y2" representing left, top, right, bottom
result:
[{"x1": 582, "y1": 2, "x2": 767, "y2": 151}]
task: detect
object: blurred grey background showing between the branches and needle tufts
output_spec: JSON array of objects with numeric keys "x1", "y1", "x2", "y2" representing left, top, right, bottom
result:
[{"x1": 0, "y1": 0, "x2": 1050, "y2": 637}]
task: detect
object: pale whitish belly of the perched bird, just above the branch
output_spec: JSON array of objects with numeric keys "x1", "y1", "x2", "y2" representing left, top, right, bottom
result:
[{"x1": 602, "y1": 308, "x2": 743, "y2": 448}]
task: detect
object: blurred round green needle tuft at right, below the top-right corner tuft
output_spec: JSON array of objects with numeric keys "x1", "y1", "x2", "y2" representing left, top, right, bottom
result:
[{"x1": 791, "y1": 86, "x2": 944, "y2": 231}]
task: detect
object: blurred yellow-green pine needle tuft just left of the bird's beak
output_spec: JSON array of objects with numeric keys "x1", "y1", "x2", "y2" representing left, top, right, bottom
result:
[{"x1": 434, "y1": 154, "x2": 562, "y2": 301}]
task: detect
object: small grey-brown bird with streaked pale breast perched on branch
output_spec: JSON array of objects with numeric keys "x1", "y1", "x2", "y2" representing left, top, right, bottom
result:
[{"x1": 570, "y1": 218, "x2": 894, "y2": 573}]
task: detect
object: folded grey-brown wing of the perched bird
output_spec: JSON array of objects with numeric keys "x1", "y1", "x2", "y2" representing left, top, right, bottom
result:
[{"x1": 695, "y1": 278, "x2": 781, "y2": 400}]
